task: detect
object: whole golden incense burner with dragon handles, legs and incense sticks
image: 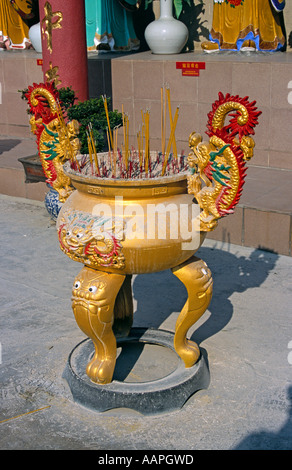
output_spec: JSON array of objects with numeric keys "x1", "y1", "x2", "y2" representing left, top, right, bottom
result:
[{"x1": 26, "y1": 87, "x2": 260, "y2": 390}]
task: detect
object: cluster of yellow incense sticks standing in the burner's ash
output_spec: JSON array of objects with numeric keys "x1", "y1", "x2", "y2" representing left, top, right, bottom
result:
[{"x1": 74, "y1": 87, "x2": 187, "y2": 179}]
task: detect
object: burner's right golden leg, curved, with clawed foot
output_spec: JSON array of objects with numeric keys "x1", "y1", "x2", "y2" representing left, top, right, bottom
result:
[{"x1": 172, "y1": 256, "x2": 213, "y2": 367}]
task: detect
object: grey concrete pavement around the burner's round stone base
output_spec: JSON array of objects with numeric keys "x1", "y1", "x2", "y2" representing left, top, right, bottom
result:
[{"x1": 0, "y1": 195, "x2": 292, "y2": 453}]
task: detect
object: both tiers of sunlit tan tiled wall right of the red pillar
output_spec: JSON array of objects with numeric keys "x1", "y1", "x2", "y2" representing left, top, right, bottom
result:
[{"x1": 112, "y1": 52, "x2": 292, "y2": 256}]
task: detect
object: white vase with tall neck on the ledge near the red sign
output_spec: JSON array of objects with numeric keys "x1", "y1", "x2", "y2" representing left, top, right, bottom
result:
[{"x1": 145, "y1": 0, "x2": 189, "y2": 54}]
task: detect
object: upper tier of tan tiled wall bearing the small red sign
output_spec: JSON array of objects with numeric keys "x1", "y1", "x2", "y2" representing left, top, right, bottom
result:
[{"x1": 112, "y1": 51, "x2": 292, "y2": 170}]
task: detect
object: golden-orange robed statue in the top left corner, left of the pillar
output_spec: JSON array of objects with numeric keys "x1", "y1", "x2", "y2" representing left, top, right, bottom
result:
[{"x1": 0, "y1": 0, "x2": 32, "y2": 50}]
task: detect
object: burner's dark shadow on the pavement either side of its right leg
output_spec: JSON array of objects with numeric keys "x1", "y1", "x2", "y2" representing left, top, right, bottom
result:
[{"x1": 133, "y1": 243, "x2": 278, "y2": 344}]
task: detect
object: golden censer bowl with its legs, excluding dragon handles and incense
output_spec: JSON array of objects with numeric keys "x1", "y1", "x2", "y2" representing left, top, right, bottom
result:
[{"x1": 57, "y1": 169, "x2": 212, "y2": 384}]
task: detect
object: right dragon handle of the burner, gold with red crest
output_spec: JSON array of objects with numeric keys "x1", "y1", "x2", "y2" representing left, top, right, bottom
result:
[{"x1": 188, "y1": 93, "x2": 261, "y2": 232}]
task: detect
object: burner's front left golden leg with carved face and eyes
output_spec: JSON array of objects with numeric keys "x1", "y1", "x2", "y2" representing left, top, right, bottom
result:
[{"x1": 72, "y1": 267, "x2": 125, "y2": 384}]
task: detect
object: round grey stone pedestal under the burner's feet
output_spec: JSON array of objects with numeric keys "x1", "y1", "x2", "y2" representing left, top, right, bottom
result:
[{"x1": 63, "y1": 328, "x2": 209, "y2": 415}]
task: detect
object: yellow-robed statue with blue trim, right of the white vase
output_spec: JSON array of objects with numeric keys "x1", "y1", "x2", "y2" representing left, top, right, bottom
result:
[{"x1": 202, "y1": 0, "x2": 286, "y2": 52}]
